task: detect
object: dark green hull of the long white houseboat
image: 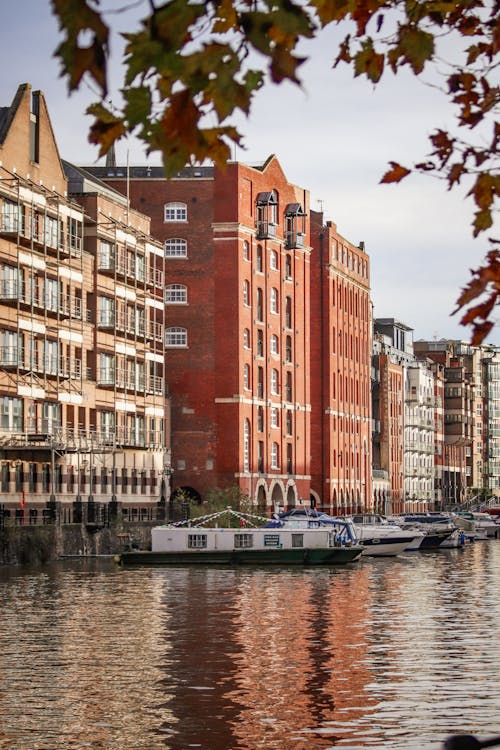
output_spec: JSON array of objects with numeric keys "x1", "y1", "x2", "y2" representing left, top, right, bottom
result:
[{"x1": 118, "y1": 546, "x2": 363, "y2": 565}]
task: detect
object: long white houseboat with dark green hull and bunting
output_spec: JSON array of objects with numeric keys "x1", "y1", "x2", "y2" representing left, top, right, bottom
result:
[{"x1": 117, "y1": 509, "x2": 363, "y2": 565}]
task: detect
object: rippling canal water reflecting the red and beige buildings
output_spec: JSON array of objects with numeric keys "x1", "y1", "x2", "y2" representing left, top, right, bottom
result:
[{"x1": 0, "y1": 540, "x2": 500, "y2": 750}]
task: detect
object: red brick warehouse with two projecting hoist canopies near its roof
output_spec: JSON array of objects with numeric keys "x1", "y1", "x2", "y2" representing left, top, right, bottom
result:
[{"x1": 90, "y1": 156, "x2": 311, "y2": 509}]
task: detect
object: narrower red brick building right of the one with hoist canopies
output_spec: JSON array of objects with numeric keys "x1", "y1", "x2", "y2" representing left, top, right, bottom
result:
[{"x1": 311, "y1": 211, "x2": 372, "y2": 513}]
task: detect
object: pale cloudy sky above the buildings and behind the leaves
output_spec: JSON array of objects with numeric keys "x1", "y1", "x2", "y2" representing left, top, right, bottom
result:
[{"x1": 0, "y1": 0, "x2": 499, "y2": 343}]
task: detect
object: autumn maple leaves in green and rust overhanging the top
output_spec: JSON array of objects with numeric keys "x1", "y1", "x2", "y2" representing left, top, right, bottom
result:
[{"x1": 51, "y1": 0, "x2": 500, "y2": 343}]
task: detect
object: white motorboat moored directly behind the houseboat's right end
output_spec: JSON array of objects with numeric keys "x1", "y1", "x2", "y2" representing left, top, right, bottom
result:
[{"x1": 350, "y1": 513, "x2": 424, "y2": 557}]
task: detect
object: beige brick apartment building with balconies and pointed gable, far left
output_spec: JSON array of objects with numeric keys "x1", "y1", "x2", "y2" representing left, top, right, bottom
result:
[{"x1": 0, "y1": 84, "x2": 170, "y2": 525}]
